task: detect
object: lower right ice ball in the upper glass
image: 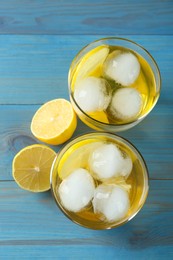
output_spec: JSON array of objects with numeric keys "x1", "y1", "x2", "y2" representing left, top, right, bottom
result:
[{"x1": 110, "y1": 88, "x2": 142, "y2": 119}]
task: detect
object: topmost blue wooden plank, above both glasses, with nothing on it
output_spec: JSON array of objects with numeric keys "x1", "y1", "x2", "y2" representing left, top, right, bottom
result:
[{"x1": 0, "y1": 0, "x2": 173, "y2": 35}]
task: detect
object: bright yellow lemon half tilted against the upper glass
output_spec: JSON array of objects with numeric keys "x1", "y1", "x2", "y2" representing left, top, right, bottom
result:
[{"x1": 31, "y1": 99, "x2": 77, "y2": 145}]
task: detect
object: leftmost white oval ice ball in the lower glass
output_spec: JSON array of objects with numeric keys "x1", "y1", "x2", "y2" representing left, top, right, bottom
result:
[{"x1": 58, "y1": 168, "x2": 95, "y2": 212}]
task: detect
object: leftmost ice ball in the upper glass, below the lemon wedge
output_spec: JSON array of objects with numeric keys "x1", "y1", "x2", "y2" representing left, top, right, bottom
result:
[{"x1": 74, "y1": 77, "x2": 111, "y2": 112}]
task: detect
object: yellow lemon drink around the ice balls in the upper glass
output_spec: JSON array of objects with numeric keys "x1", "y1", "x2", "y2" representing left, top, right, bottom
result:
[{"x1": 70, "y1": 46, "x2": 159, "y2": 124}]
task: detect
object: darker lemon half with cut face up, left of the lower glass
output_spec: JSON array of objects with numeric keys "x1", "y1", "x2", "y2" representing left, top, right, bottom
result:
[{"x1": 12, "y1": 144, "x2": 56, "y2": 192}]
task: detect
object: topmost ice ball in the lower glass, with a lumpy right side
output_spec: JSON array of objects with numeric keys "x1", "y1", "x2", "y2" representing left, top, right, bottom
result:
[{"x1": 89, "y1": 143, "x2": 133, "y2": 180}]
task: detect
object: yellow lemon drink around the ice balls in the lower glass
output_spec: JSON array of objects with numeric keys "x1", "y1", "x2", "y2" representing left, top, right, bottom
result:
[{"x1": 52, "y1": 133, "x2": 148, "y2": 229}]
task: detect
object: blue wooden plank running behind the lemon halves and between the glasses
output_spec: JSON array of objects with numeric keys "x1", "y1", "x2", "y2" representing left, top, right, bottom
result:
[{"x1": 0, "y1": 105, "x2": 173, "y2": 180}]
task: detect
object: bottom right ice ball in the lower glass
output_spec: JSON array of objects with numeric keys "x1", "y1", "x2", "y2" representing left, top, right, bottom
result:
[{"x1": 93, "y1": 184, "x2": 130, "y2": 222}]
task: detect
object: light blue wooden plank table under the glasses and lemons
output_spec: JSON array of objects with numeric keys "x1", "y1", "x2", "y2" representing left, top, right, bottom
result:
[{"x1": 0, "y1": 0, "x2": 173, "y2": 260}]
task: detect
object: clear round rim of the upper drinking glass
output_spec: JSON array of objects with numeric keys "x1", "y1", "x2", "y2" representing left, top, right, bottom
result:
[{"x1": 68, "y1": 36, "x2": 162, "y2": 127}]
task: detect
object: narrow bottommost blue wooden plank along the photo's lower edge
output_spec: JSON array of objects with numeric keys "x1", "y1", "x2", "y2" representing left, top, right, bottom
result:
[{"x1": 0, "y1": 245, "x2": 173, "y2": 260}]
